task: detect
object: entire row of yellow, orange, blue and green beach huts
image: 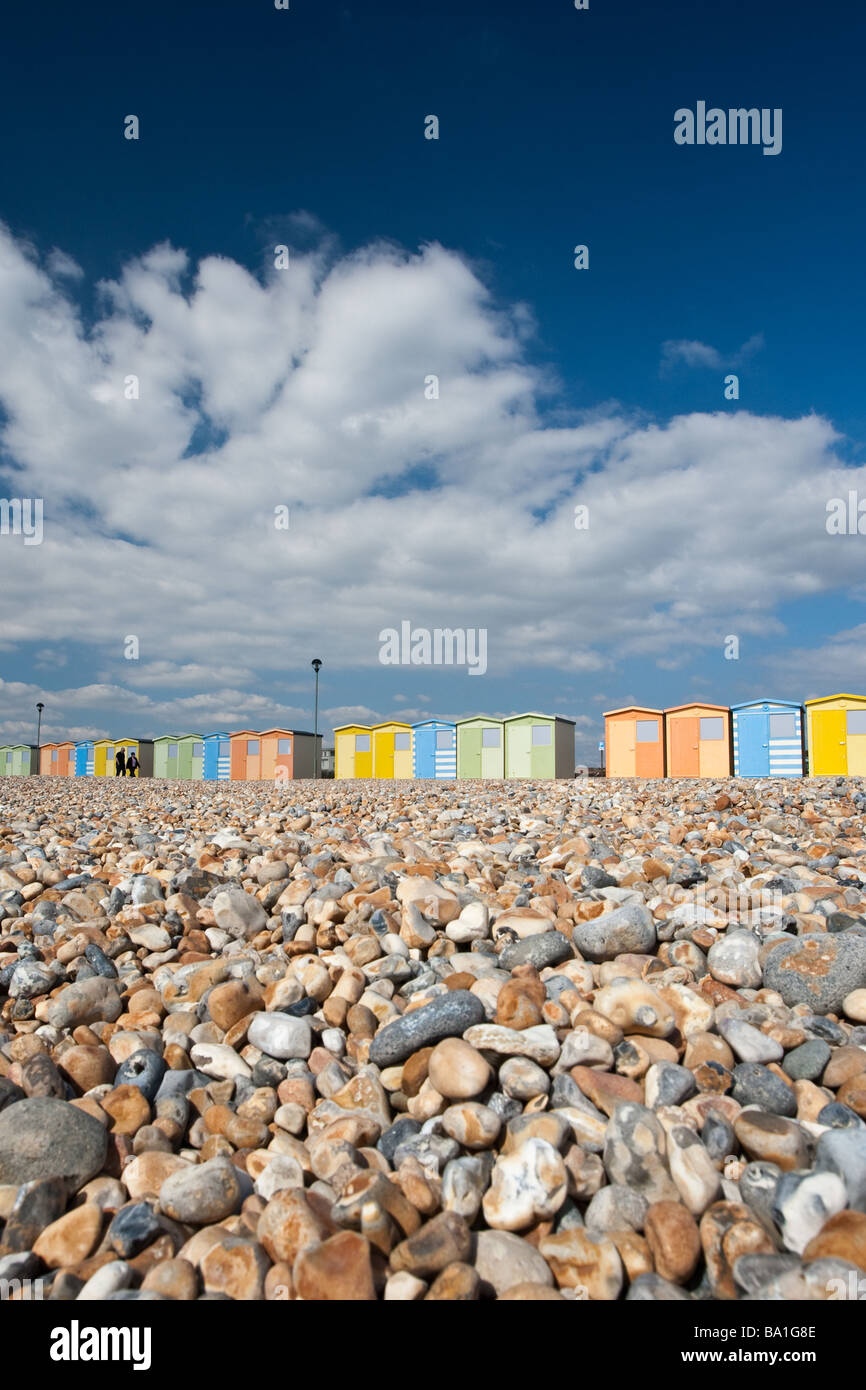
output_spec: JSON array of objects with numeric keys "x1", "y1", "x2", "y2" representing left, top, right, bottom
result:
[{"x1": 0, "y1": 695, "x2": 866, "y2": 781}]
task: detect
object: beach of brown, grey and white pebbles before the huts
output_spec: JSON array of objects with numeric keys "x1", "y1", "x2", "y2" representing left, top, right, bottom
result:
[{"x1": 0, "y1": 777, "x2": 866, "y2": 1304}]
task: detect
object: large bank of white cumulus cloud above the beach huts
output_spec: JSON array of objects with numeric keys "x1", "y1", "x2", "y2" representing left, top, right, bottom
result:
[{"x1": 0, "y1": 220, "x2": 866, "y2": 745}]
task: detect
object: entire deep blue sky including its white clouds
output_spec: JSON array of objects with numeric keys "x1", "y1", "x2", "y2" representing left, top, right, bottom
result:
[{"x1": 0, "y1": 0, "x2": 866, "y2": 755}]
